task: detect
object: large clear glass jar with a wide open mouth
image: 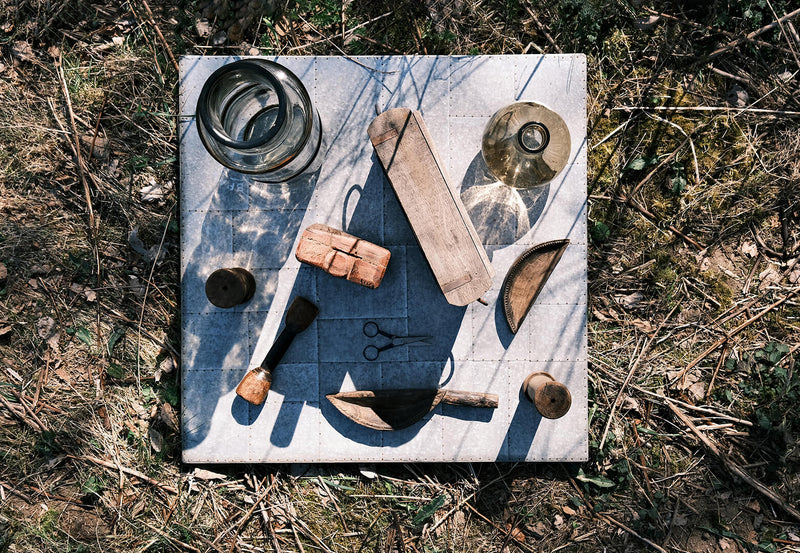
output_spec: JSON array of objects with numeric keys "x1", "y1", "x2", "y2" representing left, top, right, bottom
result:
[{"x1": 197, "y1": 59, "x2": 322, "y2": 182}]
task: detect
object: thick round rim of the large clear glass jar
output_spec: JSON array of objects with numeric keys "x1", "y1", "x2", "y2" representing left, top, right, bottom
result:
[{"x1": 197, "y1": 60, "x2": 286, "y2": 149}]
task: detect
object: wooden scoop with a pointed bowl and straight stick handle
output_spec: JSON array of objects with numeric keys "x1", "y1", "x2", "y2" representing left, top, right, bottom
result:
[{"x1": 326, "y1": 388, "x2": 498, "y2": 430}]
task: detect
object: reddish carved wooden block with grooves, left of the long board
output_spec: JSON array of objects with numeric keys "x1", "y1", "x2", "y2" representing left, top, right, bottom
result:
[{"x1": 295, "y1": 223, "x2": 392, "y2": 288}]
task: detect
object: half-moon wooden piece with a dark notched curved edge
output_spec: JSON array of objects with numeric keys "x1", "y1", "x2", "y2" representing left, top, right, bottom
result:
[{"x1": 501, "y1": 239, "x2": 569, "y2": 334}]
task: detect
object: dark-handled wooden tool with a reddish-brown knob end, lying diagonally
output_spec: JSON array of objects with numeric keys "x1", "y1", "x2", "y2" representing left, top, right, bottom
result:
[{"x1": 236, "y1": 296, "x2": 319, "y2": 405}]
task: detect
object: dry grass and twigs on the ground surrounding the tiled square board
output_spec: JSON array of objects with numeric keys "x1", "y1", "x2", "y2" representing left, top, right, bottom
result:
[{"x1": 0, "y1": 0, "x2": 800, "y2": 553}]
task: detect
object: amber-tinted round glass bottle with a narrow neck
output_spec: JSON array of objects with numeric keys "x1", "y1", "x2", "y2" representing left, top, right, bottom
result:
[{"x1": 481, "y1": 102, "x2": 571, "y2": 188}]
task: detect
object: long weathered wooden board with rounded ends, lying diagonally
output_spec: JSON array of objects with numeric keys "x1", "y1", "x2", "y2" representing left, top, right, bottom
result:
[{"x1": 367, "y1": 108, "x2": 494, "y2": 305}]
